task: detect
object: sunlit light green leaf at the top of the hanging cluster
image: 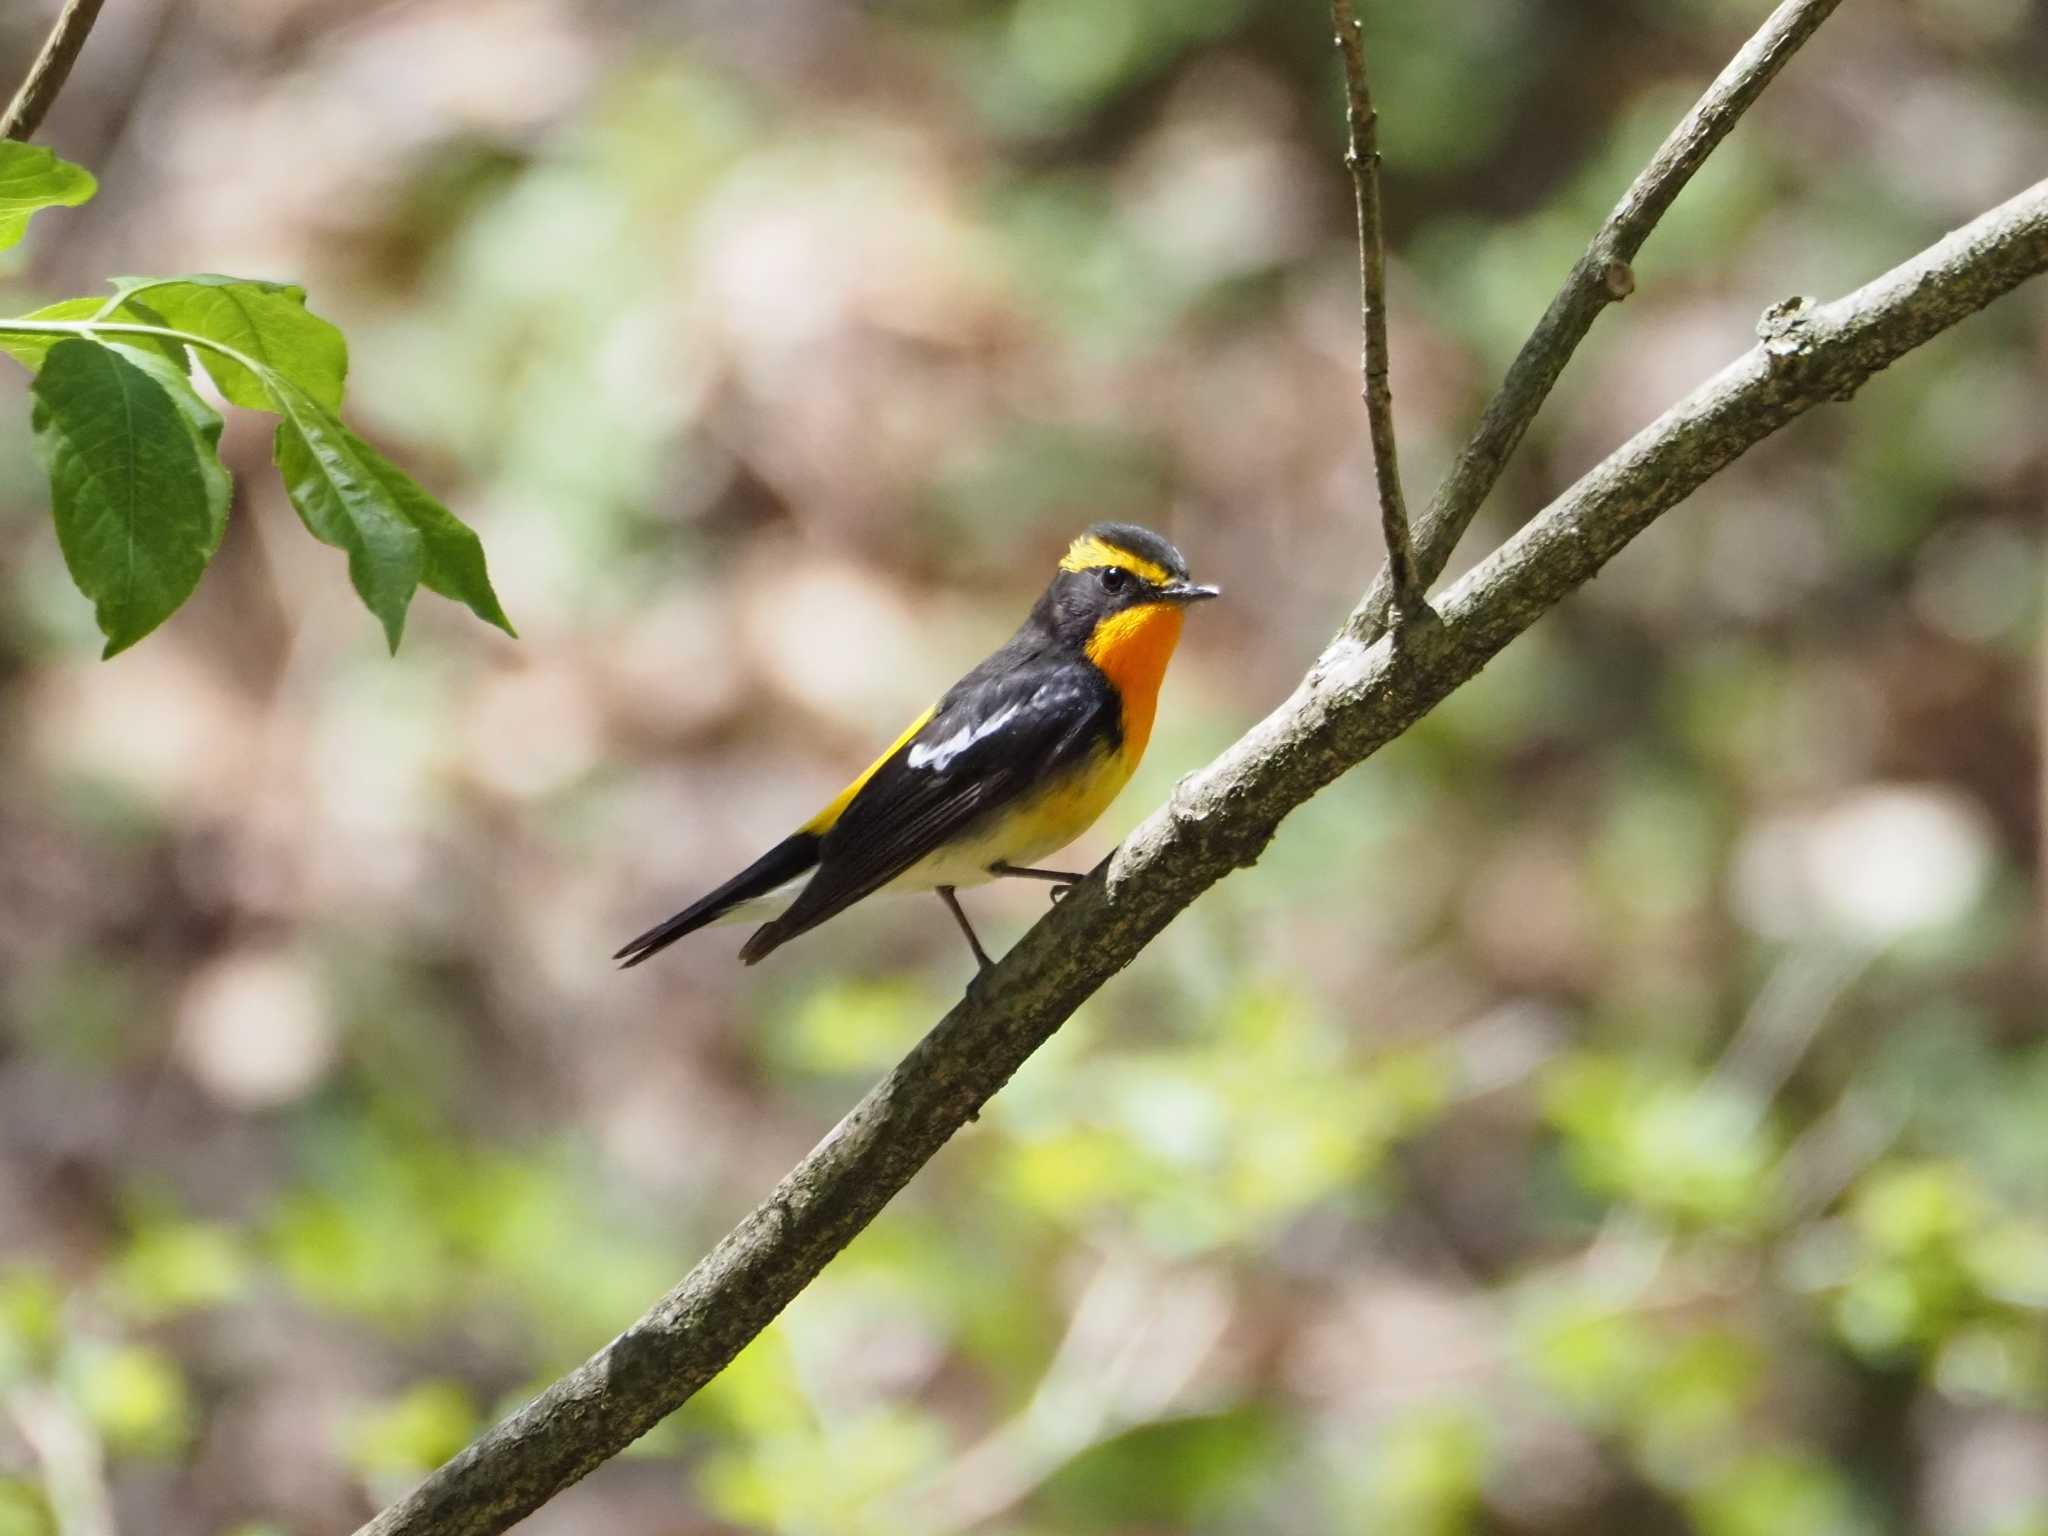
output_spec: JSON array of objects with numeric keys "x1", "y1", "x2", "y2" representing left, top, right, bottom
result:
[{"x1": 102, "y1": 272, "x2": 348, "y2": 416}]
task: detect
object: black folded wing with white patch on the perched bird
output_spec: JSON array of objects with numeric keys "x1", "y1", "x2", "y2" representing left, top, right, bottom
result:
[{"x1": 739, "y1": 651, "x2": 1122, "y2": 965}]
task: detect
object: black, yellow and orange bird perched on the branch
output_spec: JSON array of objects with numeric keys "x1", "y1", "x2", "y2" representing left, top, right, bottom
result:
[{"x1": 612, "y1": 522, "x2": 1221, "y2": 971}]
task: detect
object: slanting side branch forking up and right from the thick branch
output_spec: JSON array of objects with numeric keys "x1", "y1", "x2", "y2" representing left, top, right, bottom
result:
[{"x1": 1350, "y1": 0, "x2": 1841, "y2": 639}]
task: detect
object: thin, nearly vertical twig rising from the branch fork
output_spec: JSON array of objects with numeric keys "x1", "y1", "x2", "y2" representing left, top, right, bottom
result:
[{"x1": 1329, "y1": 0, "x2": 1423, "y2": 616}]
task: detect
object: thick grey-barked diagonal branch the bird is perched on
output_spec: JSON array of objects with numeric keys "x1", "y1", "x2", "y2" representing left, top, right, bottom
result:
[{"x1": 362, "y1": 182, "x2": 2048, "y2": 1536}]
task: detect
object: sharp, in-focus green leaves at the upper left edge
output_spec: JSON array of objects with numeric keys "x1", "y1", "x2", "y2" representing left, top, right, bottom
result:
[{"x1": 0, "y1": 143, "x2": 514, "y2": 655}]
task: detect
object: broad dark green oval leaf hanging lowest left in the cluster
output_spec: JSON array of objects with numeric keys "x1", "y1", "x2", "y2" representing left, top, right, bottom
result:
[{"x1": 31, "y1": 338, "x2": 231, "y2": 655}]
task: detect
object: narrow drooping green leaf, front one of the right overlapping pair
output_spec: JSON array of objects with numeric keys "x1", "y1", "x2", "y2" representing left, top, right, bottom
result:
[{"x1": 268, "y1": 377, "x2": 426, "y2": 653}]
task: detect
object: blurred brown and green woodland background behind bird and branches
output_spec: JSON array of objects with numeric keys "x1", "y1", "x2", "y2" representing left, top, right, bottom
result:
[{"x1": 0, "y1": 0, "x2": 2048, "y2": 1536}]
